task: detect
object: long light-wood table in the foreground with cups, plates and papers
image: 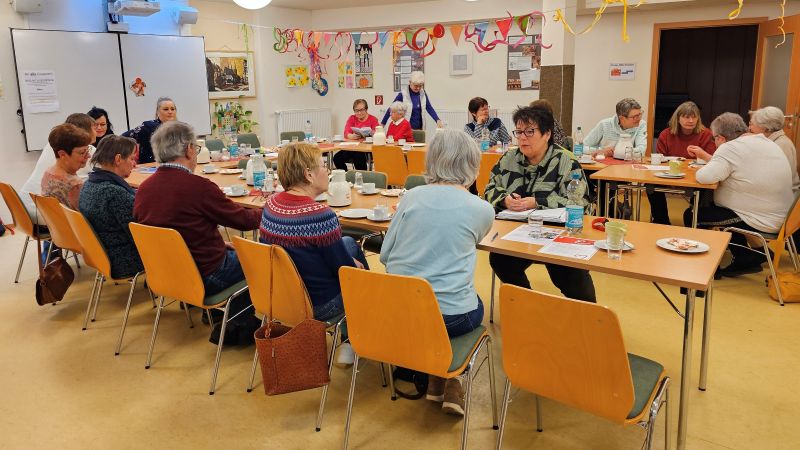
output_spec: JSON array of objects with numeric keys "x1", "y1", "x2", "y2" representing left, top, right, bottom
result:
[{"x1": 128, "y1": 165, "x2": 731, "y2": 449}]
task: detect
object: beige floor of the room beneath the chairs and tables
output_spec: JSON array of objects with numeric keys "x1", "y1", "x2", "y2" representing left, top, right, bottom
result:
[{"x1": 0, "y1": 202, "x2": 800, "y2": 449}]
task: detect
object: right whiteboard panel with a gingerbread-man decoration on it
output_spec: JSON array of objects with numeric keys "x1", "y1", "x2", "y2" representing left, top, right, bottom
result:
[{"x1": 120, "y1": 34, "x2": 211, "y2": 135}]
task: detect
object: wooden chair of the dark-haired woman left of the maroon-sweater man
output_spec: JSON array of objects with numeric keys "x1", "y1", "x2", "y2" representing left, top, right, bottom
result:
[{"x1": 61, "y1": 205, "x2": 151, "y2": 348}]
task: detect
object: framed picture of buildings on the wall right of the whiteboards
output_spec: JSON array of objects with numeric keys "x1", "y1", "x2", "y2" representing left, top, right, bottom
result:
[{"x1": 206, "y1": 52, "x2": 256, "y2": 99}]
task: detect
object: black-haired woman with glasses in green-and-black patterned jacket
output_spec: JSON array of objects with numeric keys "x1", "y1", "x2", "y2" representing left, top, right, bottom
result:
[{"x1": 484, "y1": 106, "x2": 595, "y2": 302}]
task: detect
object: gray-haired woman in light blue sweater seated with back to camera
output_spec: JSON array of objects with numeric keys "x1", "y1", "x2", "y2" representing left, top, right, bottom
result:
[{"x1": 380, "y1": 130, "x2": 494, "y2": 414}]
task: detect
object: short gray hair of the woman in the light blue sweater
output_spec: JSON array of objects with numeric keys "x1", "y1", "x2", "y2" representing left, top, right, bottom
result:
[{"x1": 425, "y1": 128, "x2": 481, "y2": 187}]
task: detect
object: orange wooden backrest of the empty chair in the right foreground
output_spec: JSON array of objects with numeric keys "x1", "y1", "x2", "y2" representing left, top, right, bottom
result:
[{"x1": 496, "y1": 284, "x2": 634, "y2": 423}]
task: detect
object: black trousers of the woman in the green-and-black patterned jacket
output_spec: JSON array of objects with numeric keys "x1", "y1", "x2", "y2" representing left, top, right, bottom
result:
[{"x1": 489, "y1": 253, "x2": 597, "y2": 303}]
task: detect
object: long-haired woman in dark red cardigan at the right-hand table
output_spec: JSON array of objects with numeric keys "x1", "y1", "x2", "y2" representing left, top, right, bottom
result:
[{"x1": 647, "y1": 102, "x2": 717, "y2": 225}]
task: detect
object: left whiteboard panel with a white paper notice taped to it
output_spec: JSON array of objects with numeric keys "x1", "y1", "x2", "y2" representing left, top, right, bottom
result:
[{"x1": 11, "y1": 29, "x2": 128, "y2": 150}]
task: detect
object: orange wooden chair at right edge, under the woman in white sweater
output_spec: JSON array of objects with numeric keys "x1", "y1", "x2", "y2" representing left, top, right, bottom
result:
[{"x1": 722, "y1": 197, "x2": 800, "y2": 306}]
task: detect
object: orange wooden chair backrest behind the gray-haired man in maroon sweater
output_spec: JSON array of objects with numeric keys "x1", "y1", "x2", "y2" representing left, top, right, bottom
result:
[{"x1": 128, "y1": 222, "x2": 206, "y2": 306}]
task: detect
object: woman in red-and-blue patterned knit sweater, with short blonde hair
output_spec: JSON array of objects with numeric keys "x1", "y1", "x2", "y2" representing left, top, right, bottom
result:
[{"x1": 259, "y1": 142, "x2": 369, "y2": 365}]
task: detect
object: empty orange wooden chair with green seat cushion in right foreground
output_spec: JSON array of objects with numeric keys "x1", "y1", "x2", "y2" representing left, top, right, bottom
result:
[{"x1": 496, "y1": 284, "x2": 670, "y2": 450}]
